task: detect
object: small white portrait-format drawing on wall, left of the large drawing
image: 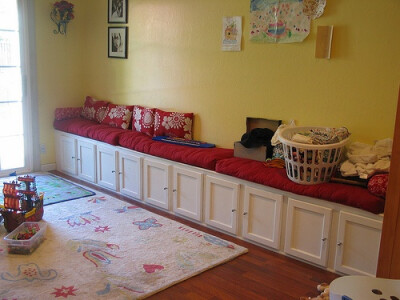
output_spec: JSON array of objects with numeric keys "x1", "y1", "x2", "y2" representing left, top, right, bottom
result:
[{"x1": 222, "y1": 17, "x2": 242, "y2": 51}]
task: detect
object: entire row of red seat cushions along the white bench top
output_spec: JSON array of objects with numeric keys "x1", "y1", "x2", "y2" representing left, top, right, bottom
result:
[{"x1": 54, "y1": 118, "x2": 384, "y2": 214}]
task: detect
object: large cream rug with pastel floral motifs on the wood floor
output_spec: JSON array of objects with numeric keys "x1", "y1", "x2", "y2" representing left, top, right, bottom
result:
[{"x1": 0, "y1": 192, "x2": 247, "y2": 299}]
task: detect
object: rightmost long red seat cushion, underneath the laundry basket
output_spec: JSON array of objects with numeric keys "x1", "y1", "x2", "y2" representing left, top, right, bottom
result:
[{"x1": 215, "y1": 157, "x2": 385, "y2": 214}]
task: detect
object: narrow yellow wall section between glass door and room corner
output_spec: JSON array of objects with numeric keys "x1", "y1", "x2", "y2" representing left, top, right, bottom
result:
[{"x1": 35, "y1": 0, "x2": 85, "y2": 164}]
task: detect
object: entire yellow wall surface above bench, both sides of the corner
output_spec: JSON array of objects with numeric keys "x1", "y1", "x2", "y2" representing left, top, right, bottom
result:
[{"x1": 36, "y1": 0, "x2": 400, "y2": 163}]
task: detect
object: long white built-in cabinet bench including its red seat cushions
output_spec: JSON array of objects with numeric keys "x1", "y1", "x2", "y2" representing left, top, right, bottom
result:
[{"x1": 54, "y1": 116, "x2": 384, "y2": 276}]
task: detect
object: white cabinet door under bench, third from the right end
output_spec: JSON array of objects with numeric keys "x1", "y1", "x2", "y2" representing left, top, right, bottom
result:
[{"x1": 243, "y1": 186, "x2": 283, "y2": 249}]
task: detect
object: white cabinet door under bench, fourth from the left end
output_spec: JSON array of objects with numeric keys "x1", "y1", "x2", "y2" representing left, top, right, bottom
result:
[{"x1": 118, "y1": 151, "x2": 143, "y2": 200}]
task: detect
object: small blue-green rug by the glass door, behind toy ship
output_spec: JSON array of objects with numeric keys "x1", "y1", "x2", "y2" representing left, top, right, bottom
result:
[{"x1": 0, "y1": 173, "x2": 95, "y2": 205}]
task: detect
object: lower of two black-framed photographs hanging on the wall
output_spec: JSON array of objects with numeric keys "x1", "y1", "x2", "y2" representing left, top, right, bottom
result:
[{"x1": 108, "y1": 26, "x2": 128, "y2": 58}]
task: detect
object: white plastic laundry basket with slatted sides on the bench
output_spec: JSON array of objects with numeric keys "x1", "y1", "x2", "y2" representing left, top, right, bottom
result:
[{"x1": 278, "y1": 127, "x2": 349, "y2": 185}]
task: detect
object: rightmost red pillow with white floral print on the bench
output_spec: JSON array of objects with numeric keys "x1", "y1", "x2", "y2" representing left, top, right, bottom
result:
[{"x1": 154, "y1": 109, "x2": 193, "y2": 140}]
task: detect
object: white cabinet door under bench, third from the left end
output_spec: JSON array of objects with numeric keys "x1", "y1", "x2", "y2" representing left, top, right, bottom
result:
[{"x1": 97, "y1": 145, "x2": 117, "y2": 191}]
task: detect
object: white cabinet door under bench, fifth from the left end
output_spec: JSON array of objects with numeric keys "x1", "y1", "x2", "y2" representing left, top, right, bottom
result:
[{"x1": 143, "y1": 159, "x2": 170, "y2": 210}]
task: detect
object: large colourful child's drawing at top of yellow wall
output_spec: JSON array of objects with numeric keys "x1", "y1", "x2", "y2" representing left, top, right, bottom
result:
[{"x1": 250, "y1": 0, "x2": 311, "y2": 43}]
